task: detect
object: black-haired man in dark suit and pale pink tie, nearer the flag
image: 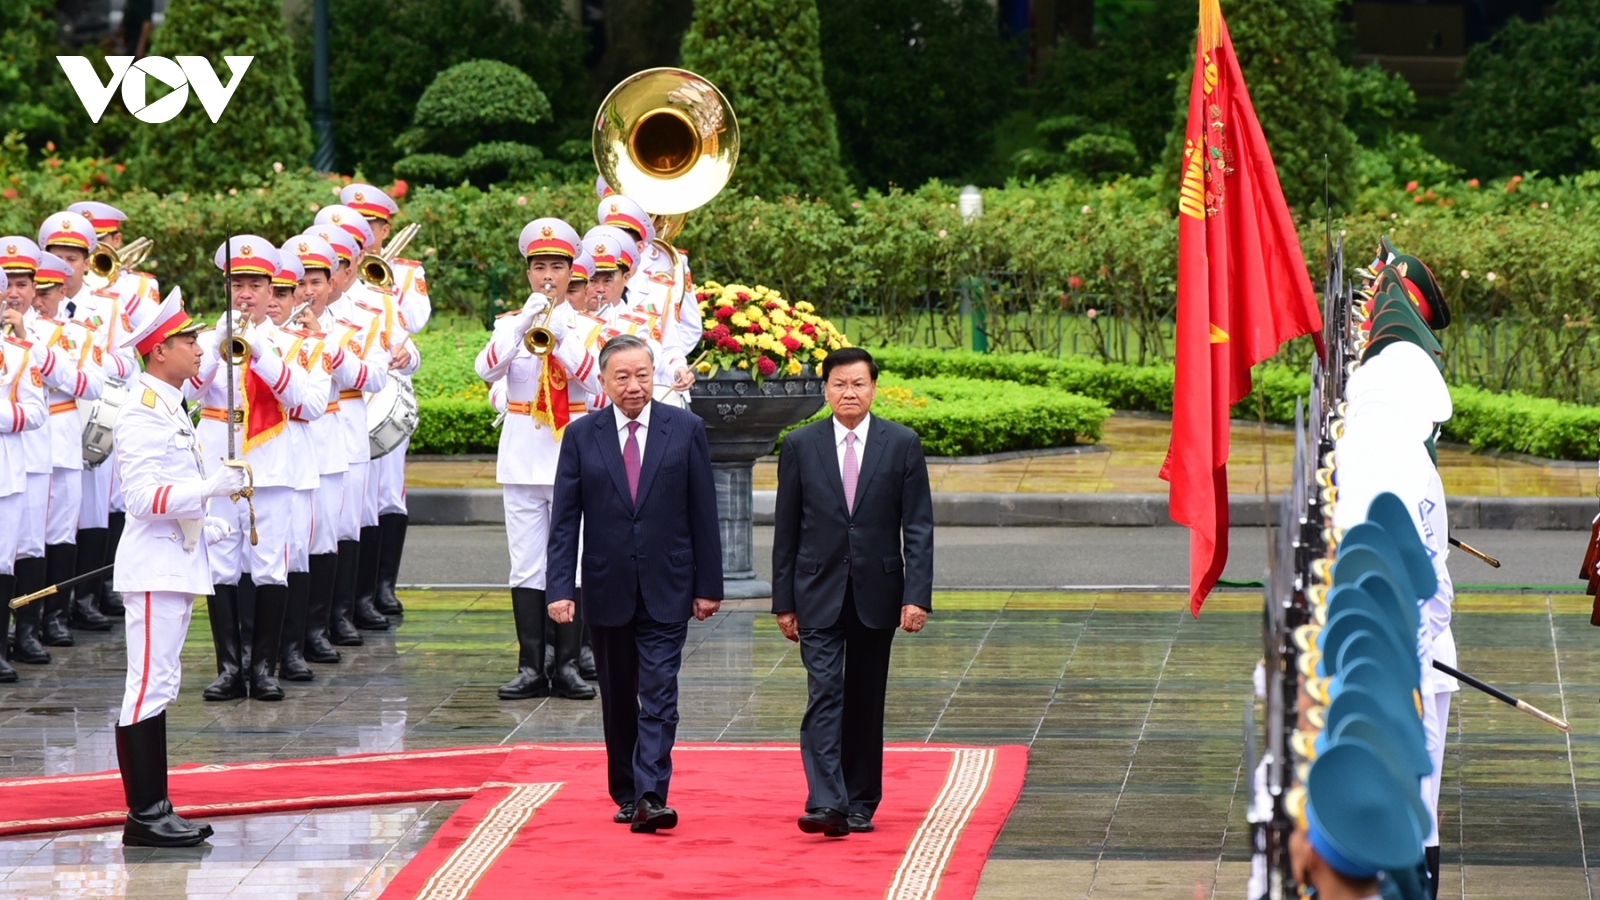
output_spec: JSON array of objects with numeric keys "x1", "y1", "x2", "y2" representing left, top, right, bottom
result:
[{"x1": 773, "y1": 348, "x2": 933, "y2": 838}]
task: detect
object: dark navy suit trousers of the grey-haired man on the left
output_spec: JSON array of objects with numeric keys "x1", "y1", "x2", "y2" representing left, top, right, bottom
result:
[{"x1": 589, "y1": 588, "x2": 690, "y2": 806}]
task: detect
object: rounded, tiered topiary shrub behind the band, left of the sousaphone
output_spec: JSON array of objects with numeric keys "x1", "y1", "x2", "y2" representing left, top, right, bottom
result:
[{"x1": 395, "y1": 59, "x2": 568, "y2": 187}]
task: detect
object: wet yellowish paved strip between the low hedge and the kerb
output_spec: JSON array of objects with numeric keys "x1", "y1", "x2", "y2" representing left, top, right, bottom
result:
[{"x1": 406, "y1": 415, "x2": 1597, "y2": 496}]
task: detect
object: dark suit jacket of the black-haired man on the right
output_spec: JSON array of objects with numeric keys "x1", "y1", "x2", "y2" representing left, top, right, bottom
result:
[{"x1": 773, "y1": 416, "x2": 933, "y2": 628}]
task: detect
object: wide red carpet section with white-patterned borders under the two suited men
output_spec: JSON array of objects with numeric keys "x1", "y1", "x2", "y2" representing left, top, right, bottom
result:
[{"x1": 382, "y1": 745, "x2": 1027, "y2": 900}]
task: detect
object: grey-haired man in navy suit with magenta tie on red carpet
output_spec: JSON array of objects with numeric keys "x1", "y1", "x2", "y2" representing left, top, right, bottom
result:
[{"x1": 547, "y1": 335, "x2": 722, "y2": 833}]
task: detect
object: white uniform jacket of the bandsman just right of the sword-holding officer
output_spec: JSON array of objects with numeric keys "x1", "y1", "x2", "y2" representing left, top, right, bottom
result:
[{"x1": 185, "y1": 320, "x2": 322, "y2": 486}]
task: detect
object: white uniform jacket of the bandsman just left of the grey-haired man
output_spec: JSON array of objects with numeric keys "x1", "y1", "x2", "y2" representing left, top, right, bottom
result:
[{"x1": 475, "y1": 297, "x2": 600, "y2": 485}]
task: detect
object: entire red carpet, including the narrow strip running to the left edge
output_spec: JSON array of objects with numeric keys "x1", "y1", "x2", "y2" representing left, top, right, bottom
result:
[{"x1": 0, "y1": 745, "x2": 1027, "y2": 900}]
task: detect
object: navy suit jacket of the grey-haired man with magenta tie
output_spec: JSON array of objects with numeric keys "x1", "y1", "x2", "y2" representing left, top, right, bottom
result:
[{"x1": 546, "y1": 404, "x2": 722, "y2": 626}]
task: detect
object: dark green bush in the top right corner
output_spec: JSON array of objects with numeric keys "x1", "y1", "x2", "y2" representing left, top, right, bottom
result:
[{"x1": 1442, "y1": 0, "x2": 1600, "y2": 175}]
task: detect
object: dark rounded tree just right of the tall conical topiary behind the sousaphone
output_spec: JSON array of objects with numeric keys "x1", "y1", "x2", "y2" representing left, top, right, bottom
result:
[{"x1": 819, "y1": 0, "x2": 1024, "y2": 189}]
